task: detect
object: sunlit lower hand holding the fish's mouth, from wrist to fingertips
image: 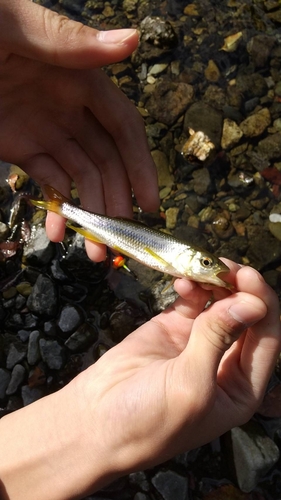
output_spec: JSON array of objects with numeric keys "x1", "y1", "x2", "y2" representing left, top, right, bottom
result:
[{"x1": 75, "y1": 261, "x2": 281, "y2": 474}]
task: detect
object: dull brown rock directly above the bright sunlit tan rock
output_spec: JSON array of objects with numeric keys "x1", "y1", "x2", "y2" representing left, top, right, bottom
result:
[{"x1": 184, "y1": 101, "x2": 223, "y2": 148}]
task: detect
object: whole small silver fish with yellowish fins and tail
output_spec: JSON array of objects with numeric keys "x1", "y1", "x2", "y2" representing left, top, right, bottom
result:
[{"x1": 30, "y1": 186, "x2": 232, "y2": 288}]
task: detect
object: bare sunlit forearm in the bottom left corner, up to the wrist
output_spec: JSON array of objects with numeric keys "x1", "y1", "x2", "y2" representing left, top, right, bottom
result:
[{"x1": 0, "y1": 384, "x2": 114, "y2": 500}]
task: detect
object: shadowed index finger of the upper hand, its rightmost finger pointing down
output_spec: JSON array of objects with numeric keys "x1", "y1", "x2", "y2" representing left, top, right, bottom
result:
[{"x1": 82, "y1": 70, "x2": 159, "y2": 211}]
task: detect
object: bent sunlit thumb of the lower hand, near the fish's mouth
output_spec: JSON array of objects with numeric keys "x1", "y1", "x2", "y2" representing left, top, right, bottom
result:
[{"x1": 183, "y1": 292, "x2": 267, "y2": 380}]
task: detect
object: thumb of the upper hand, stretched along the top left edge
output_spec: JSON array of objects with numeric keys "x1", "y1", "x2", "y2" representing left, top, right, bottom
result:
[{"x1": 0, "y1": 0, "x2": 138, "y2": 69}]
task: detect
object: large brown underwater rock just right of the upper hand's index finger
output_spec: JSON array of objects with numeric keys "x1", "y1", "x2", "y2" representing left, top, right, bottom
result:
[{"x1": 146, "y1": 81, "x2": 193, "y2": 125}]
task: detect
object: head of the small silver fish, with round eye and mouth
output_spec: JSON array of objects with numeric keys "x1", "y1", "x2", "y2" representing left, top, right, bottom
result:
[{"x1": 177, "y1": 249, "x2": 231, "y2": 288}]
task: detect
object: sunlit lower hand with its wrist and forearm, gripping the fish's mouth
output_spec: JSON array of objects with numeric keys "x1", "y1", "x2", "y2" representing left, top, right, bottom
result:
[{"x1": 0, "y1": 259, "x2": 281, "y2": 500}]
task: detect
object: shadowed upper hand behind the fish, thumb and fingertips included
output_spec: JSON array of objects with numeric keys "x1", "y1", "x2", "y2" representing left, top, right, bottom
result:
[{"x1": 0, "y1": 0, "x2": 158, "y2": 260}]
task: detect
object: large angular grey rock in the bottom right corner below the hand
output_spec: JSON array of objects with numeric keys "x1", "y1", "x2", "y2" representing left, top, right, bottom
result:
[{"x1": 230, "y1": 421, "x2": 280, "y2": 492}]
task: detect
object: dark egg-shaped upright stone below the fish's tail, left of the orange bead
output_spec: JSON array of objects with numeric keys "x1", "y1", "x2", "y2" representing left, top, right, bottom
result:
[{"x1": 26, "y1": 274, "x2": 58, "y2": 317}]
